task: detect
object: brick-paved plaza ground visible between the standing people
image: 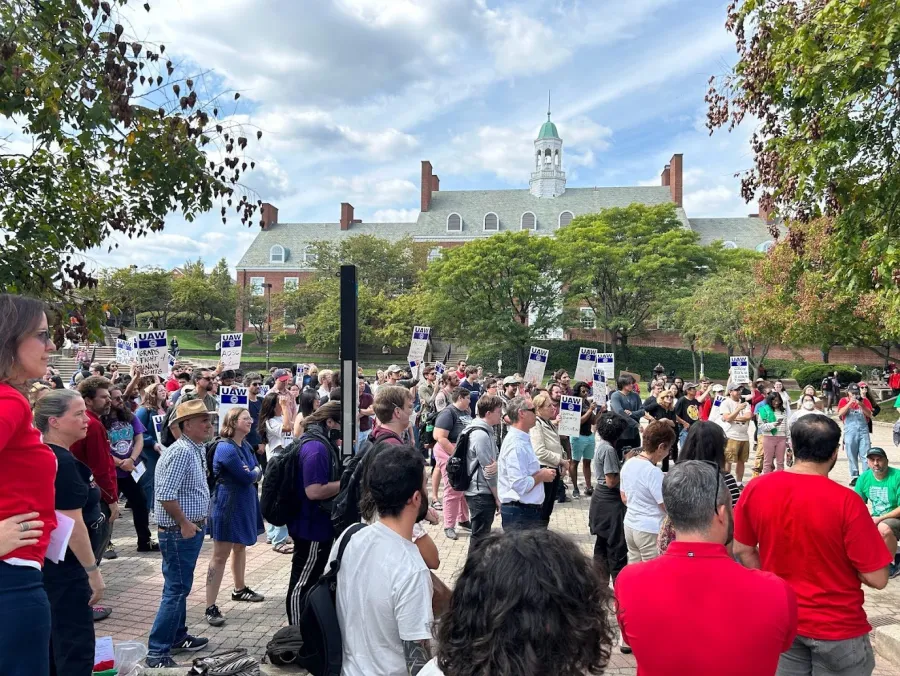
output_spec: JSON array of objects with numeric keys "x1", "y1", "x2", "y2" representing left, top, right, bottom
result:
[{"x1": 95, "y1": 426, "x2": 900, "y2": 676}]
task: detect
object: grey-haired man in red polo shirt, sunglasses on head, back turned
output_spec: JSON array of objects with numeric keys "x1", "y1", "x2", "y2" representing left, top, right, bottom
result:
[{"x1": 616, "y1": 460, "x2": 797, "y2": 676}]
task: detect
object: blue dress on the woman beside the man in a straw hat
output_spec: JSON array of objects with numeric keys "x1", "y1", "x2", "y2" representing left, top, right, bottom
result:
[{"x1": 210, "y1": 439, "x2": 264, "y2": 545}]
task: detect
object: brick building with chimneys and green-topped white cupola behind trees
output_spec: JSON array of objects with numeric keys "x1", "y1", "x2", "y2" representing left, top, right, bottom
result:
[{"x1": 235, "y1": 111, "x2": 772, "y2": 331}]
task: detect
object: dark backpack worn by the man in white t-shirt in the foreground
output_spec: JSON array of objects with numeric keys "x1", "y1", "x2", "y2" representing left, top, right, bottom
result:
[{"x1": 296, "y1": 523, "x2": 366, "y2": 676}]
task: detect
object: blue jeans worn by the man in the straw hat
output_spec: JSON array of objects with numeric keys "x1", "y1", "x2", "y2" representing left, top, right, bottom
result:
[{"x1": 148, "y1": 528, "x2": 205, "y2": 657}]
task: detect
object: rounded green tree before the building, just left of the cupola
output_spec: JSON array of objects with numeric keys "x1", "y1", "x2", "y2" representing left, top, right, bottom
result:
[{"x1": 423, "y1": 232, "x2": 561, "y2": 369}]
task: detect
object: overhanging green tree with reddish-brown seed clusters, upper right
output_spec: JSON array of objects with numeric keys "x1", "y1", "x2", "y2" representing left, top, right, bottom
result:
[{"x1": 707, "y1": 0, "x2": 900, "y2": 343}]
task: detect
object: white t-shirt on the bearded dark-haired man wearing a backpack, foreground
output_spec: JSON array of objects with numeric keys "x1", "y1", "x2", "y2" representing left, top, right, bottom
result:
[{"x1": 328, "y1": 522, "x2": 434, "y2": 676}]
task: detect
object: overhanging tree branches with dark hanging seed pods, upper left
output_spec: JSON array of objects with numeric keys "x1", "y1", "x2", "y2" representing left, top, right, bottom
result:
[{"x1": 0, "y1": 0, "x2": 260, "y2": 296}]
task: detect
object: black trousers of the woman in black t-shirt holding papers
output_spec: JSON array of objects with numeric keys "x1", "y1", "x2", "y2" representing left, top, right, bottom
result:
[{"x1": 44, "y1": 562, "x2": 94, "y2": 676}]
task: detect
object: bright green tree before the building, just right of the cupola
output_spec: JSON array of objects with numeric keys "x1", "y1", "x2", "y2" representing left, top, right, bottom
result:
[{"x1": 556, "y1": 204, "x2": 715, "y2": 346}]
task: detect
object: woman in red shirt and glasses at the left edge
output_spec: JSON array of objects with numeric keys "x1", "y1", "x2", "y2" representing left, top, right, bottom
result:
[{"x1": 0, "y1": 294, "x2": 56, "y2": 676}]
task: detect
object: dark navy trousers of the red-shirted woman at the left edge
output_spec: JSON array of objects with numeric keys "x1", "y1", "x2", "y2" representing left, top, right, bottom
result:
[{"x1": 0, "y1": 562, "x2": 51, "y2": 676}]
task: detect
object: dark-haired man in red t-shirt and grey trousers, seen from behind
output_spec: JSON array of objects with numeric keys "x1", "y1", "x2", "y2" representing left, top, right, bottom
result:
[{"x1": 734, "y1": 415, "x2": 893, "y2": 676}]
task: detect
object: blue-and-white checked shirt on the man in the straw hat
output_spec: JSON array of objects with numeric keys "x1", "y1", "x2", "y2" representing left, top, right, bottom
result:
[{"x1": 154, "y1": 434, "x2": 209, "y2": 528}]
